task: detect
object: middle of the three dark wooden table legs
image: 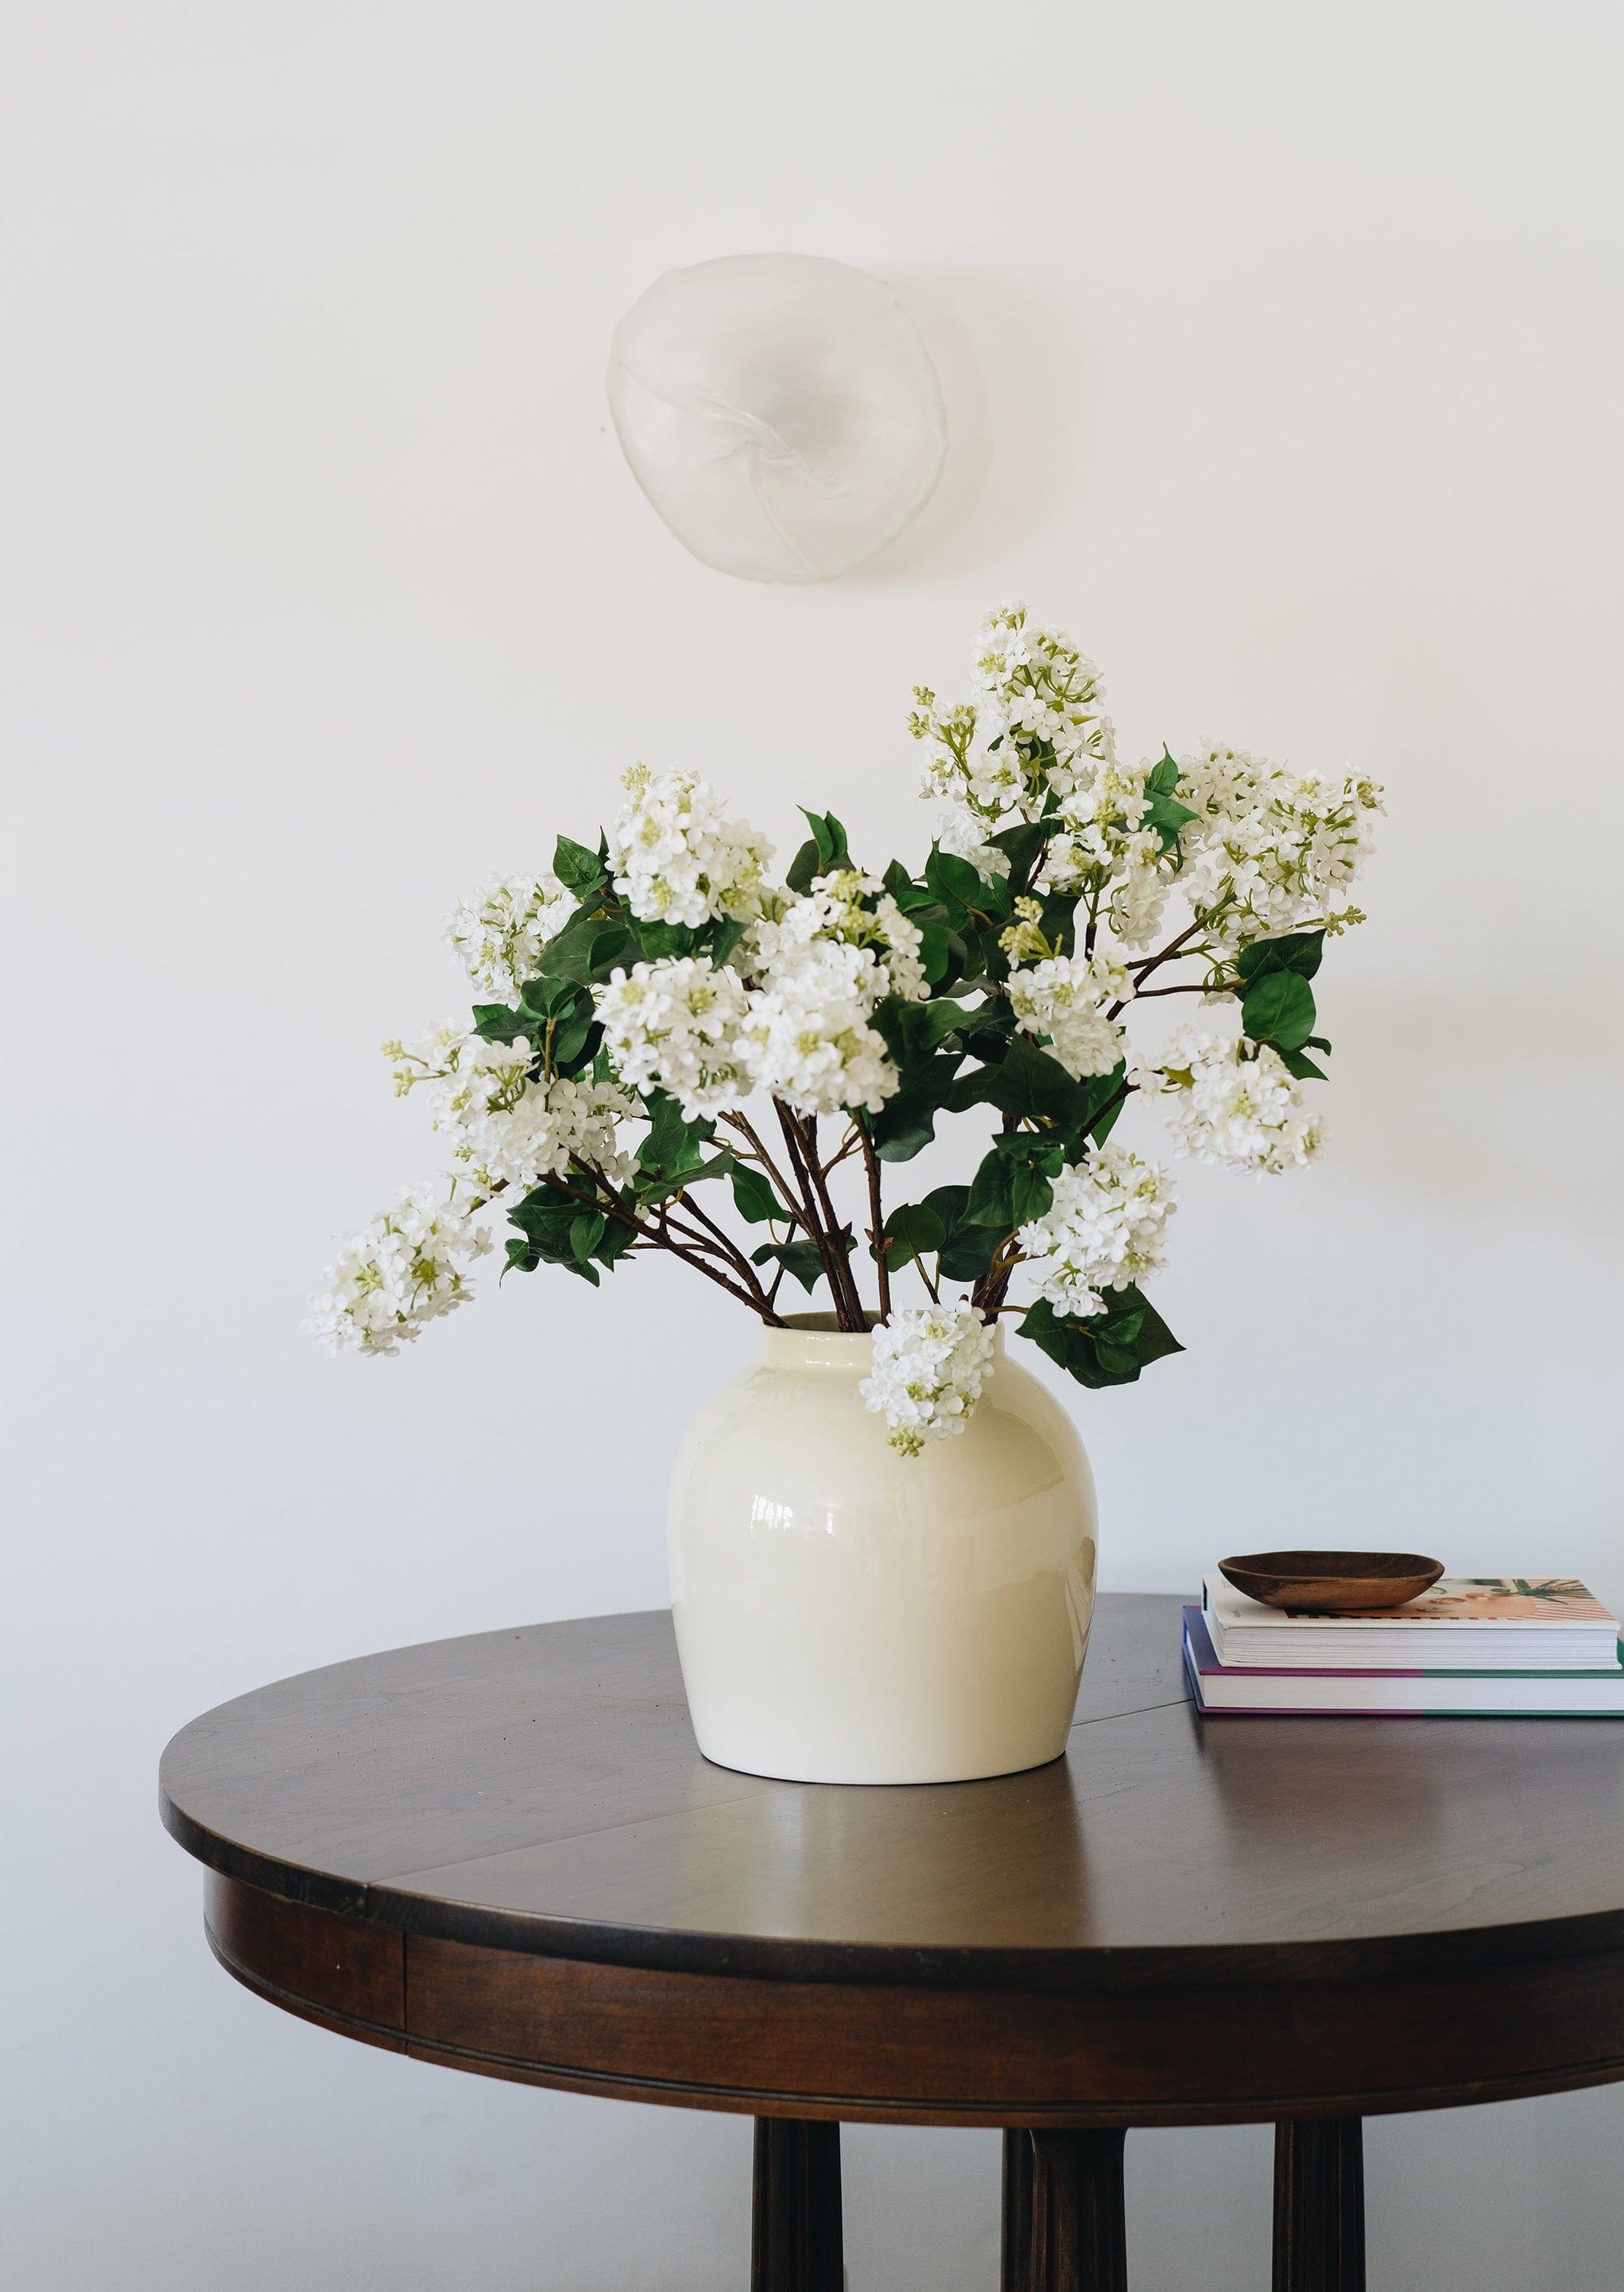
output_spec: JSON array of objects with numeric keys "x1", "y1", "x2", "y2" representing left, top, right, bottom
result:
[{"x1": 1003, "y1": 2129, "x2": 1127, "y2": 2292}]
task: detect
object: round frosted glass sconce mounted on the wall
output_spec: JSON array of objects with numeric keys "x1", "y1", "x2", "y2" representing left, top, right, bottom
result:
[{"x1": 609, "y1": 254, "x2": 948, "y2": 582}]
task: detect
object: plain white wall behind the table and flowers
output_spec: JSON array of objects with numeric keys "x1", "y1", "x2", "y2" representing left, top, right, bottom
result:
[{"x1": 0, "y1": 0, "x2": 1624, "y2": 2292}]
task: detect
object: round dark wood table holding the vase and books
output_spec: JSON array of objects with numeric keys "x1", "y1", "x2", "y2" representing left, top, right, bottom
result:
[{"x1": 163, "y1": 1596, "x2": 1624, "y2": 2292}]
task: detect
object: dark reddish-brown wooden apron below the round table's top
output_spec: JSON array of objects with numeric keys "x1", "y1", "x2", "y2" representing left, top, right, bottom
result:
[{"x1": 206, "y1": 1872, "x2": 1624, "y2": 2125}]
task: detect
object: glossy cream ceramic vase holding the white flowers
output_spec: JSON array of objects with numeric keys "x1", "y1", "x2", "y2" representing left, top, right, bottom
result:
[{"x1": 671, "y1": 1313, "x2": 1097, "y2": 1783}]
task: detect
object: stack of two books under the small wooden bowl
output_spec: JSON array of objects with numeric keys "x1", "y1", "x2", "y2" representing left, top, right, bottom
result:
[{"x1": 1184, "y1": 1575, "x2": 1624, "y2": 1719}]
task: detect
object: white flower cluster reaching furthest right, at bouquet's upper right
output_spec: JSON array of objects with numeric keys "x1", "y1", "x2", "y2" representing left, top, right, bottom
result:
[{"x1": 1177, "y1": 745, "x2": 1383, "y2": 953}]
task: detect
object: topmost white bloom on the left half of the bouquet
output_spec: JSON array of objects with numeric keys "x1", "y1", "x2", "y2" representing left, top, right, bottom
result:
[{"x1": 609, "y1": 763, "x2": 772, "y2": 929}]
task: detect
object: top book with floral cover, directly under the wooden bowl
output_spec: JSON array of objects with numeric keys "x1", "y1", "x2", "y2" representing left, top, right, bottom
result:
[{"x1": 1203, "y1": 1575, "x2": 1619, "y2": 1671}]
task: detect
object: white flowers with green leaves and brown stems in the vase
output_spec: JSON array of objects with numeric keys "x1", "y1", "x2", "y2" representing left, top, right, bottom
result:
[{"x1": 309, "y1": 605, "x2": 1382, "y2": 1456}]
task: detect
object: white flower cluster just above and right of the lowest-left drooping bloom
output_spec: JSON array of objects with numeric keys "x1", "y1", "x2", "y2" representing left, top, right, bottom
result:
[{"x1": 385, "y1": 1027, "x2": 637, "y2": 1194}]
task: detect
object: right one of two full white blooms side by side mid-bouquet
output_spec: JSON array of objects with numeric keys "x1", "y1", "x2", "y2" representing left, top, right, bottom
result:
[{"x1": 742, "y1": 940, "x2": 900, "y2": 1114}]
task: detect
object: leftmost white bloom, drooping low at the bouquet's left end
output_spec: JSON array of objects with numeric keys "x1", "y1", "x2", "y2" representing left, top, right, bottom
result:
[{"x1": 304, "y1": 1181, "x2": 490, "y2": 1352}]
